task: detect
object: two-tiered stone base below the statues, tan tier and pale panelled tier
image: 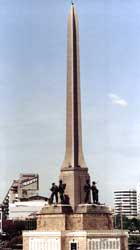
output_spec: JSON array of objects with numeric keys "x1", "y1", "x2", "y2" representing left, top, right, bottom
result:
[{"x1": 23, "y1": 204, "x2": 128, "y2": 250}]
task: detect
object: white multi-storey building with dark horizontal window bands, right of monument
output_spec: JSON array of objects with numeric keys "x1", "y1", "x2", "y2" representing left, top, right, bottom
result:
[{"x1": 114, "y1": 189, "x2": 137, "y2": 218}]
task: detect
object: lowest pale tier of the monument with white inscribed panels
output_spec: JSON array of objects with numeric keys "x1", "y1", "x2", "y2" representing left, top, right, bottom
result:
[{"x1": 23, "y1": 230, "x2": 128, "y2": 250}]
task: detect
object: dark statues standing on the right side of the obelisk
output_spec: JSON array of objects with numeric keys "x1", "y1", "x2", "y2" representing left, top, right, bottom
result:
[{"x1": 84, "y1": 180, "x2": 99, "y2": 204}]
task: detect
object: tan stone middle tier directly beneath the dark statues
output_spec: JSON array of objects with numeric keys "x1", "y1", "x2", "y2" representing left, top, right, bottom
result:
[{"x1": 37, "y1": 204, "x2": 113, "y2": 231}]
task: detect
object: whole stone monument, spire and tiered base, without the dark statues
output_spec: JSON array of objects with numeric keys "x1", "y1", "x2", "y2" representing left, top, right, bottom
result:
[{"x1": 23, "y1": 4, "x2": 128, "y2": 250}]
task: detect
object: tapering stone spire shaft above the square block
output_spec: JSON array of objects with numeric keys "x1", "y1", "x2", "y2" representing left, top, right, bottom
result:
[{"x1": 62, "y1": 4, "x2": 86, "y2": 168}]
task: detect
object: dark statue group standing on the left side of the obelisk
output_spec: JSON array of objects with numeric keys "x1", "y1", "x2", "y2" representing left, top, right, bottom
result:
[{"x1": 49, "y1": 180, "x2": 69, "y2": 204}]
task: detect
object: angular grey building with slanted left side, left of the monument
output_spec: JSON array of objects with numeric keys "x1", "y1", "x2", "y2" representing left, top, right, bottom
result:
[{"x1": 2, "y1": 173, "x2": 39, "y2": 218}]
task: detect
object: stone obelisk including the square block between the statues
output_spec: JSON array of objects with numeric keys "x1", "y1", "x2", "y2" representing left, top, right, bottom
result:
[{"x1": 60, "y1": 4, "x2": 90, "y2": 209}]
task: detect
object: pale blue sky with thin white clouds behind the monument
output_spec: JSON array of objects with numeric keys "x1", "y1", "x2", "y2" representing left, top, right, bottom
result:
[{"x1": 0, "y1": 0, "x2": 140, "y2": 204}]
